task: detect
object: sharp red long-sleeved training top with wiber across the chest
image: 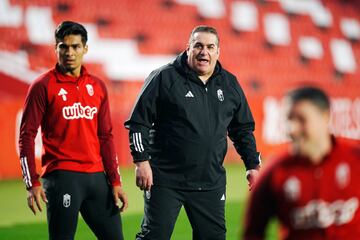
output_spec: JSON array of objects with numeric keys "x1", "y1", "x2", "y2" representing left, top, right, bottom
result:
[{"x1": 19, "y1": 66, "x2": 121, "y2": 189}]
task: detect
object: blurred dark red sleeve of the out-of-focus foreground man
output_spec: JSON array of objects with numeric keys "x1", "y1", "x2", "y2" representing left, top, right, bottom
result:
[{"x1": 244, "y1": 164, "x2": 276, "y2": 240}]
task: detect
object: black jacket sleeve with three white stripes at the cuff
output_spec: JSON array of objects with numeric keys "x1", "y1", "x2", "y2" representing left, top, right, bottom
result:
[{"x1": 124, "y1": 71, "x2": 160, "y2": 162}]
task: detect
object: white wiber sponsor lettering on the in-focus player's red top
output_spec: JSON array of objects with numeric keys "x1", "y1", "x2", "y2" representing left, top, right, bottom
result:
[{"x1": 62, "y1": 102, "x2": 97, "y2": 120}]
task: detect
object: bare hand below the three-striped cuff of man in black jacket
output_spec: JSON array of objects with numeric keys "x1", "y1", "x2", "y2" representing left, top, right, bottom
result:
[{"x1": 135, "y1": 161, "x2": 153, "y2": 191}]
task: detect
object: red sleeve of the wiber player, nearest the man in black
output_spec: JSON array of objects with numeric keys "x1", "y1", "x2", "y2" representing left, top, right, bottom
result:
[{"x1": 98, "y1": 79, "x2": 121, "y2": 186}]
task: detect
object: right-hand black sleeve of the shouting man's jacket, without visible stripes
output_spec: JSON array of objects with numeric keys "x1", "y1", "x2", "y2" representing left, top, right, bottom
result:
[{"x1": 228, "y1": 79, "x2": 261, "y2": 170}]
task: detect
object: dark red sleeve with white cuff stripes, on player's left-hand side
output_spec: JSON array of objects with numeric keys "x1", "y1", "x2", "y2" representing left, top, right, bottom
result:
[{"x1": 19, "y1": 78, "x2": 47, "y2": 189}]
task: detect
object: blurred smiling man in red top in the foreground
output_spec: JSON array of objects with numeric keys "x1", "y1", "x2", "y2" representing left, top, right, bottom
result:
[{"x1": 243, "y1": 87, "x2": 360, "y2": 240}]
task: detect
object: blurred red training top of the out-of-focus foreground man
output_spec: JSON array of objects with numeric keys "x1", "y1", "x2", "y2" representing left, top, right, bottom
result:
[{"x1": 244, "y1": 139, "x2": 360, "y2": 240}]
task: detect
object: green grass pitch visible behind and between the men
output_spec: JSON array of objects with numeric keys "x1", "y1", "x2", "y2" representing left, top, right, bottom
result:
[{"x1": 0, "y1": 164, "x2": 277, "y2": 240}]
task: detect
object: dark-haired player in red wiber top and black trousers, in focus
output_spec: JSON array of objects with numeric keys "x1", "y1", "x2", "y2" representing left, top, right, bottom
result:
[{"x1": 19, "y1": 21, "x2": 128, "y2": 240}]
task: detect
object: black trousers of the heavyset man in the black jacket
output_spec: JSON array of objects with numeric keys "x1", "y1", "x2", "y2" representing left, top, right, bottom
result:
[{"x1": 136, "y1": 186, "x2": 226, "y2": 240}]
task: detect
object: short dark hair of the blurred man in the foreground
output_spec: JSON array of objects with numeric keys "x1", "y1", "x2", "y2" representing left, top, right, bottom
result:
[{"x1": 286, "y1": 87, "x2": 330, "y2": 111}]
